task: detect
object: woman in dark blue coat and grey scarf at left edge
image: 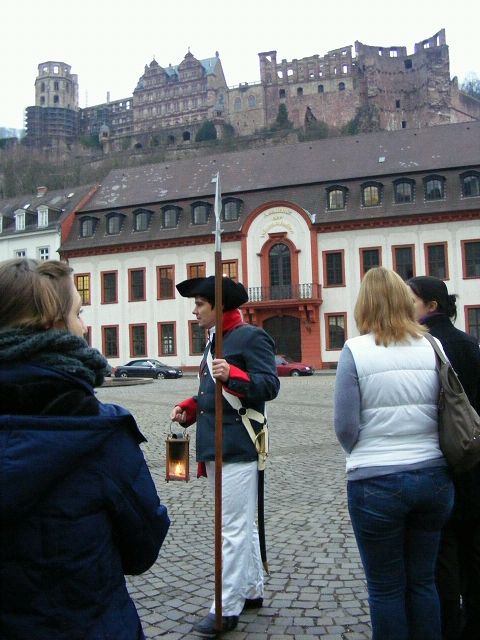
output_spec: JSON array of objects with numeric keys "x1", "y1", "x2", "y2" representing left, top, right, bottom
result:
[{"x1": 0, "y1": 259, "x2": 169, "y2": 640}]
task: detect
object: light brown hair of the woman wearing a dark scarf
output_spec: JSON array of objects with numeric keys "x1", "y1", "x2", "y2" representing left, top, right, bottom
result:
[{"x1": 0, "y1": 258, "x2": 73, "y2": 330}]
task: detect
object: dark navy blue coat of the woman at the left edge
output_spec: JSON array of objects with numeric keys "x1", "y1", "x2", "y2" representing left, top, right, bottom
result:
[{"x1": 0, "y1": 366, "x2": 169, "y2": 640}]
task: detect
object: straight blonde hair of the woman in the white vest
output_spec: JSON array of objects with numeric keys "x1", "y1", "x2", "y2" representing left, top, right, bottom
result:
[{"x1": 354, "y1": 267, "x2": 425, "y2": 347}]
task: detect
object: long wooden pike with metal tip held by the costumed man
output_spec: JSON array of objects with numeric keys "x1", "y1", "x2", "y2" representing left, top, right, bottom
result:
[{"x1": 212, "y1": 173, "x2": 223, "y2": 631}]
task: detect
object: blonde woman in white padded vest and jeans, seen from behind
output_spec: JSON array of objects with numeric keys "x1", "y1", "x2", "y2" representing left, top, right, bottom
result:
[{"x1": 335, "y1": 267, "x2": 453, "y2": 640}]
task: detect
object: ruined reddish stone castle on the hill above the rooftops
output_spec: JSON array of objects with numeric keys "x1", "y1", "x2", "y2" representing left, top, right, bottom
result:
[{"x1": 22, "y1": 29, "x2": 480, "y2": 152}]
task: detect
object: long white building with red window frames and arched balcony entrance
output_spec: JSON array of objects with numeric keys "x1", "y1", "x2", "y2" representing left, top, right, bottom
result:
[{"x1": 60, "y1": 122, "x2": 480, "y2": 367}]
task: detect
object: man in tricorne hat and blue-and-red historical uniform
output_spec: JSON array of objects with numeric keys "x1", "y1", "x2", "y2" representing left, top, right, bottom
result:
[{"x1": 171, "y1": 276, "x2": 280, "y2": 637}]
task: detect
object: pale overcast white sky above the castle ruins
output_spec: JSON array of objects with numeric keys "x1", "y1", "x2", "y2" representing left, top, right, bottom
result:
[{"x1": 0, "y1": 0, "x2": 480, "y2": 129}]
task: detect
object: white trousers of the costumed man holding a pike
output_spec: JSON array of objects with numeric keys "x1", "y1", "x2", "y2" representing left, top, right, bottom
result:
[{"x1": 206, "y1": 462, "x2": 263, "y2": 616}]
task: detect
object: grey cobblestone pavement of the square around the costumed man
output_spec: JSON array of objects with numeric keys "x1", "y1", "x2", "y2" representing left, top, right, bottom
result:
[{"x1": 99, "y1": 375, "x2": 371, "y2": 640}]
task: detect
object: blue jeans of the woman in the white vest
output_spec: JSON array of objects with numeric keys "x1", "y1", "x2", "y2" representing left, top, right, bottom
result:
[{"x1": 348, "y1": 467, "x2": 454, "y2": 640}]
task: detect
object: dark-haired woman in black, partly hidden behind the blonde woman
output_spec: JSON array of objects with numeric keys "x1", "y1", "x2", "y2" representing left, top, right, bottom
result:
[{"x1": 407, "y1": 276, "x2": 480, "y2": 640}]
